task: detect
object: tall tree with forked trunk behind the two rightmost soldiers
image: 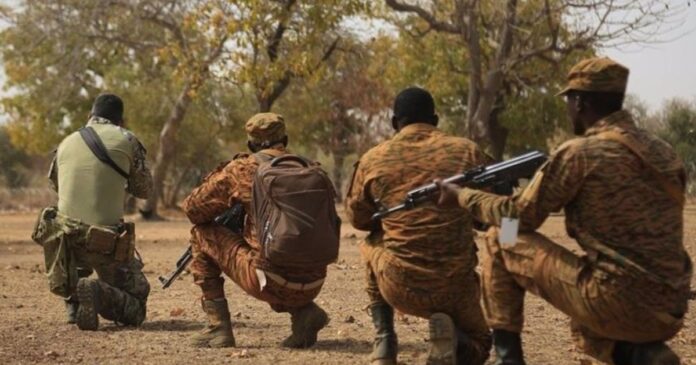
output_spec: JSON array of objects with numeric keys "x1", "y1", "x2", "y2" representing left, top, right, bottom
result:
[{"x1": 385, "y1": 0, "x2": 686, "y2": 158}]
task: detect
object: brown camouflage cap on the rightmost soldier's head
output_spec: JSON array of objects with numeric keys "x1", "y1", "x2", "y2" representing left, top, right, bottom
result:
[{"x1": 556, "y1": 57, "x2": 628, "y2": 95}]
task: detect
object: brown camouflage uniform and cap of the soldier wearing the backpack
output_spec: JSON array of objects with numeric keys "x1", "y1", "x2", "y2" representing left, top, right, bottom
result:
[{"x1": 183, "y1": 113, "x2": 326, "y2": 312}]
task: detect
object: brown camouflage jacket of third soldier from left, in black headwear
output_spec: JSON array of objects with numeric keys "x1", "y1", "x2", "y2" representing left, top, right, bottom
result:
[{"x1": 345, "y1": 123, "x2": 491, "y2": 273}]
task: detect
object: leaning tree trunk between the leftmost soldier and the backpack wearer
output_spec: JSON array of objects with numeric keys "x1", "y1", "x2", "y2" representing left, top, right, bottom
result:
[{"x1": 140, "y1": 81, "x2": 193, "y2": 219}]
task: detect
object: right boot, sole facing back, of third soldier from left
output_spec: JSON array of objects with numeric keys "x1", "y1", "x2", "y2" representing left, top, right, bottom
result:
[{"x1": 426, "y1": 313, "x2": 457, "y2": 365}]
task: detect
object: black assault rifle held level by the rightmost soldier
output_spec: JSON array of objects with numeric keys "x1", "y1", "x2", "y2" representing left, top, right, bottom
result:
[{"x1": 372, "y1": 151, "x2": 546, "y2": 222}]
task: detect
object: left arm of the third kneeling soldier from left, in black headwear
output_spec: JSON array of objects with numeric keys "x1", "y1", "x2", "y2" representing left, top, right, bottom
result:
[{"x1": 345, "y1": 161, "x2": 378, "y2": 231}]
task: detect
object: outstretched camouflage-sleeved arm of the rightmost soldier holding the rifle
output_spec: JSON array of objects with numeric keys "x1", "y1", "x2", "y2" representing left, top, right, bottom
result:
[{"x1": 459, "y1": 144, "x2": 586, "y2": 231}]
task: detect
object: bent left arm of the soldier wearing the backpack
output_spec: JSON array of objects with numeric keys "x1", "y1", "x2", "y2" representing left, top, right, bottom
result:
[{"x1": 183, "y1": 161, "x2": 237, "y2": 224}]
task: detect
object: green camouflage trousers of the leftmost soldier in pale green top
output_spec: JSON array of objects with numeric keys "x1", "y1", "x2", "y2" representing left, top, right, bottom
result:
[{"x1": 32, "y1": 208, "x2": 150, "y2": 325}]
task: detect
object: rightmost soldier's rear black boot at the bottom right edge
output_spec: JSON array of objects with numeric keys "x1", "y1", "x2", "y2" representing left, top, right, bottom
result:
[{"x1": 613, "y1": 342, "x2": 680, "y2": 365}]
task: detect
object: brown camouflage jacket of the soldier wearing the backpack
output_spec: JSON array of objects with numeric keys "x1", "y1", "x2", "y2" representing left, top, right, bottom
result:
[{"x1": 183, "y1": 148, "x2": 326, "y2": 282}]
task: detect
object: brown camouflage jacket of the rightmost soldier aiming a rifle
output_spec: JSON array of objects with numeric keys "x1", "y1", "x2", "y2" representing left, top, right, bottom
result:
[{"x1": 459, "y1": 111, "x2": 691, "y2": 298}]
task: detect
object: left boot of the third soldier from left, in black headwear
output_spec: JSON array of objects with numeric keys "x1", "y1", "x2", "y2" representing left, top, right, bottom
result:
[{"x1": 369, "y1": 303, "x2": 399, "y2": 365}]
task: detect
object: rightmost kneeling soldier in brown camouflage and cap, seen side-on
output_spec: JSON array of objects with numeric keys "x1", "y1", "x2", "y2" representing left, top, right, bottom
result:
[{"x1": 440, "y1": 58, "x2": 692, "y2": 365}]
